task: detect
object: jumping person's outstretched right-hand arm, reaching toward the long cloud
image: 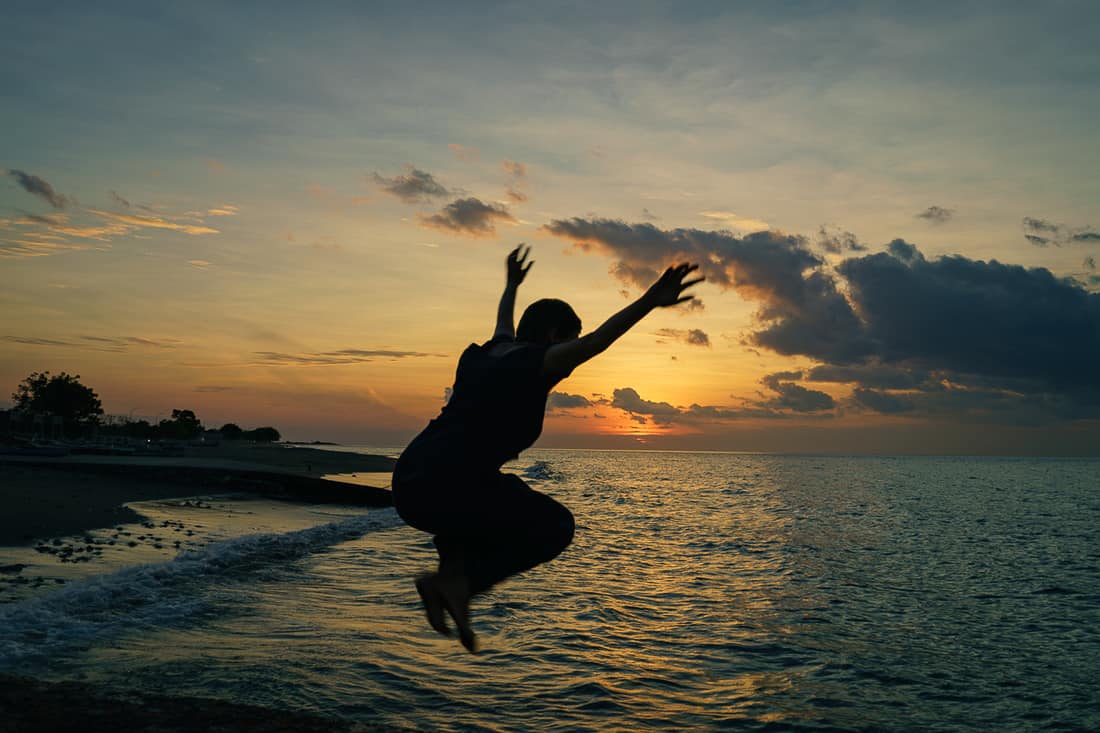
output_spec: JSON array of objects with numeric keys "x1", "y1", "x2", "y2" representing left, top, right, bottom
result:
[{"x1": 542, "y1": 262, "x2": 704, "y2": 374}]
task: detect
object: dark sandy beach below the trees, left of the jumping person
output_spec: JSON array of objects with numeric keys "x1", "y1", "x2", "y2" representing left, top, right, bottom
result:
[{"x1": 0, "y1": 446, "x2": 395, "y2": 546}]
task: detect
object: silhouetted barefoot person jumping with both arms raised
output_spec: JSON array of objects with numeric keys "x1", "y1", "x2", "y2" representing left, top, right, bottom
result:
[{"x1": 393, "y1": 244, "x2": 703, "y2": 652}]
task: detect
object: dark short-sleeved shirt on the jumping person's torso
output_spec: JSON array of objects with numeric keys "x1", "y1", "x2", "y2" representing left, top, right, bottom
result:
[{"x1": 397, "y1": 336, "x2": 568, "y2": 479}]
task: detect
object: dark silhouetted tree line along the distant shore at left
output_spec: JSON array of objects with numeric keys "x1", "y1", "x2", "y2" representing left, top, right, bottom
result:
[{"x1": 7, "y1": 372, "x2": 282, "y2": 442}]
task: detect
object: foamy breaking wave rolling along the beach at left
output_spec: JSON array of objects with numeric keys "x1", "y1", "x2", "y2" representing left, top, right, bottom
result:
[{"x1": 0, "y1": 508, "x2": 402, "y2": 671}]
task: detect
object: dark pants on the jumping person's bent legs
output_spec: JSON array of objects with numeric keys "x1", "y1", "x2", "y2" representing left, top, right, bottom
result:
[{"x1": 394, "y1": 471, "x2": 573, "y2": 593}]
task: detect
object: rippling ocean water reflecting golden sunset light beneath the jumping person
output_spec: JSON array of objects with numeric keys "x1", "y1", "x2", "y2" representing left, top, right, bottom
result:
[{"x1": 0, "y1": 450, "x2": 1100, "y2": 731}]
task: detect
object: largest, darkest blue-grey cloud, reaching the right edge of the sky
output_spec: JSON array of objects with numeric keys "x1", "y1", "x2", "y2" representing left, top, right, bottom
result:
[{"x1": 831, "y1": 245, "x2": 1100, "y2": 390}]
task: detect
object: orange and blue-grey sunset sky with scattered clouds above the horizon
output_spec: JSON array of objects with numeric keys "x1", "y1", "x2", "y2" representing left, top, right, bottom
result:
[{"x1": 0, "y1": 1, "x2": 1100, "y2": 455}]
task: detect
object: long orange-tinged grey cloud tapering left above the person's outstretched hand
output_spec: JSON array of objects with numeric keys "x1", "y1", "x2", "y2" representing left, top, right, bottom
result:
[{"x1": 543, "y1": 218, "x2": 869, "y2": 362}]
